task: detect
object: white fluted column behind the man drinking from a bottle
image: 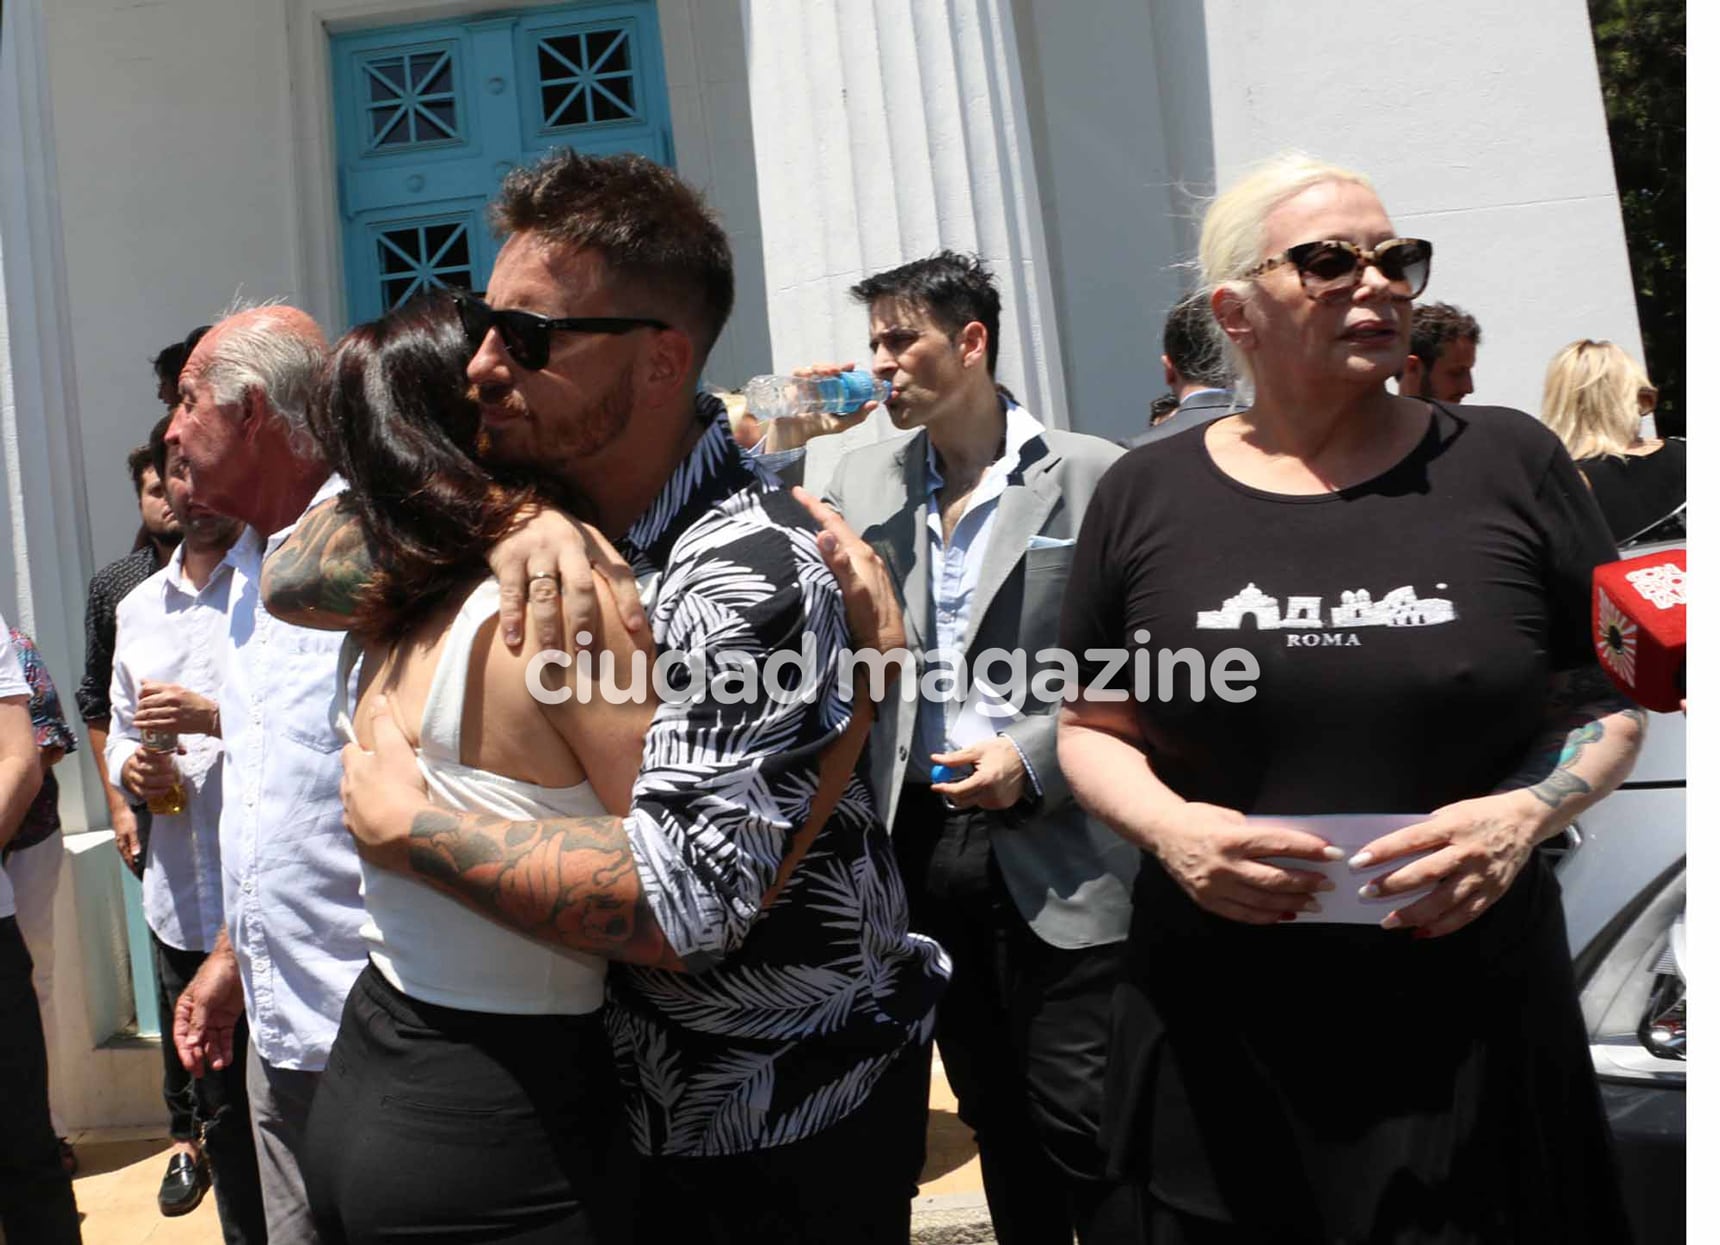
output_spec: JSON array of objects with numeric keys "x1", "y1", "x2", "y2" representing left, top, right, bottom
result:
[{"x1": 743, "y1": 0, "x2": 1068, "y2": 453}]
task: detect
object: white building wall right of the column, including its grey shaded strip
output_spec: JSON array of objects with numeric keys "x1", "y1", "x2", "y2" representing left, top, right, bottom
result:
[{"x1": 1015, "y1": 0, "x2": 1641, "y2": 437}]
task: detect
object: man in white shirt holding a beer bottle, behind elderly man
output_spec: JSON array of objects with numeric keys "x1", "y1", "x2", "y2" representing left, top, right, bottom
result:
[{"x1": 107, "y1": 439, "x2": 265, "y2": 1245}]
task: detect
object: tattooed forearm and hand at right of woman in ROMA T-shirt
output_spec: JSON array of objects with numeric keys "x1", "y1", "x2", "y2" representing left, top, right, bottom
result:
[{"x1": 1350, "y1": 665, "x2": 1646, "y2": 937}]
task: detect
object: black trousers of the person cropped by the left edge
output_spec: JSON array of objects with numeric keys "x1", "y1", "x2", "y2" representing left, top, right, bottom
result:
[{"x1": 0, "y1": 917, "x2": 83, "y2": 1245}]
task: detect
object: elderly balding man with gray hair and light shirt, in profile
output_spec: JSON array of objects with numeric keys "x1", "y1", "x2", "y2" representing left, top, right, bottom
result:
[{"x1": 167, "y1": 306, "x2": 365, "y2": 1245}]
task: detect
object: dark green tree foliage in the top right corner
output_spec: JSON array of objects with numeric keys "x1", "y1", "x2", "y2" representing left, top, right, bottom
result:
[{"x1": 1589, "y1": 0, "x2": 1686, "y2": 435}]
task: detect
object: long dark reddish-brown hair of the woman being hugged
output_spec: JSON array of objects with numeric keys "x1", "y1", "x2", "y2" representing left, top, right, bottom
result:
[{"x1": 308, "y1": 291, "x2": 531, "y2": 640}]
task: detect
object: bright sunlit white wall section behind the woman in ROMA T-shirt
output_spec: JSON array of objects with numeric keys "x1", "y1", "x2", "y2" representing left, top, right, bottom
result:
[{"x1": 1206, "y1": 0, "x2": 1641, "y2": 411}]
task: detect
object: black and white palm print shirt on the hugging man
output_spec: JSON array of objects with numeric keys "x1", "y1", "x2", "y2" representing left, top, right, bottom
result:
[{"x1": 609, "y1": 399, "x2": 949, "y2": 1156}]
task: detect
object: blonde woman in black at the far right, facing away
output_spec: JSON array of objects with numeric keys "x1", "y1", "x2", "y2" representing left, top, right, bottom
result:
[{"x1": 1541, "y1": 337, "x2": 1684, "y2": 545}]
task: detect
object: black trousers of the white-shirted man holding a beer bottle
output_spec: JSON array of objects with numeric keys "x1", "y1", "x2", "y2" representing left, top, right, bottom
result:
[{"x1": 150, "y1": 934, "x2": 268, "y2": 1245}]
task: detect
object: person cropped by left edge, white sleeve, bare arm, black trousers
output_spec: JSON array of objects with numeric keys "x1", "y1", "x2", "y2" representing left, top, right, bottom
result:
[{"x1": 0, "y1": 617, "x2": 81, "y2": 1245}]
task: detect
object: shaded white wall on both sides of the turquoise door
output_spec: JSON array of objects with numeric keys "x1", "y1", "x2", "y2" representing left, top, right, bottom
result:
[{"x1": 46, "y1": 0, "x2": 767, "y2": 566}]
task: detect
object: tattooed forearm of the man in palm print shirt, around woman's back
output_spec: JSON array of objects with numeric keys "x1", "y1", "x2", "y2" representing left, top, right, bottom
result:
[{"x1": 408, "y1": 808, "x2": 676, "y2": 966}]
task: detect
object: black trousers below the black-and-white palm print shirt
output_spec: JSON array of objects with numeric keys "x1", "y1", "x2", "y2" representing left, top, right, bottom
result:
[{"x1": 636, "y1": 1047, "x2": 931, "y2": 1245}]
